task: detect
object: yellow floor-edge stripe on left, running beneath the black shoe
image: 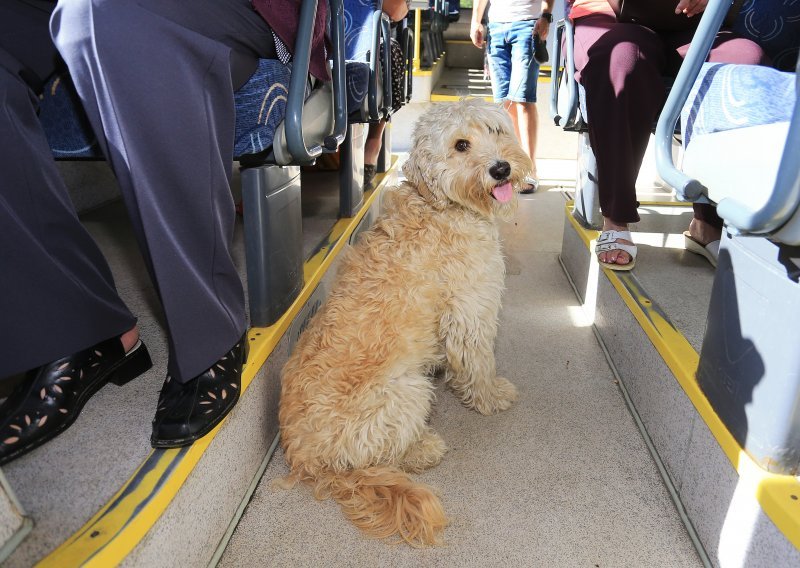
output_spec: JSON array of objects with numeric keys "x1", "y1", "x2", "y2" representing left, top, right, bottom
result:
[{"x1": 37, "y1": 162, "x2": 396, "y2": 568}]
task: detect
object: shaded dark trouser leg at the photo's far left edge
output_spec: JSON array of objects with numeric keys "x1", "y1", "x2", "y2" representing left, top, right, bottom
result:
[{"x1": 0, "y1": 1, "x2": 136, "y2": 379}]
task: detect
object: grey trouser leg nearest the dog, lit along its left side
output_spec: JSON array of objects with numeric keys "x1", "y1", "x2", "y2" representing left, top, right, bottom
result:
[{"x1": 51, "y1": 0, "x2": 274, "y2": 382}]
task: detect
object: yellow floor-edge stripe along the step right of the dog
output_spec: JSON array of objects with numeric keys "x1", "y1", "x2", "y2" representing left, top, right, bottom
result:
[{"x1": 566, "y1": 201, "x2": 800, "y2": 549}]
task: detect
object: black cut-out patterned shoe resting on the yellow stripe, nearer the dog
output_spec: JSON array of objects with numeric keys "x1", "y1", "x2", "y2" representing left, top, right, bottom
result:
[{"x1": 150, "y1": 334, "x2": 248, "y2": 448}]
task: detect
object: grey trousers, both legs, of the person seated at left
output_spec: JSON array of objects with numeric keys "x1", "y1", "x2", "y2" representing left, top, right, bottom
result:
[{"x1": 0, "y1": 0, "x2": 275, "y2": 381}]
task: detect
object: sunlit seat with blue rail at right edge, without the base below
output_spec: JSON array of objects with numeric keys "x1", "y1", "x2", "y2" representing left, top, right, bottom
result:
[{"x1": 656, "y1": 2, "x2": 800, "y2": 244}]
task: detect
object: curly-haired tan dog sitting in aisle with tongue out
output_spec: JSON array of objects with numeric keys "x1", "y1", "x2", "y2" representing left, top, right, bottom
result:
[{"x1": 280, "y1": 100, "x2": 531, "y2": 546}]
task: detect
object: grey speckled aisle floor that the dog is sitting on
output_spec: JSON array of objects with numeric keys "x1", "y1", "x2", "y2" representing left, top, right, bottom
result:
[{"x1": 221, "y1": 191, "x2": 699, "y2": 567}]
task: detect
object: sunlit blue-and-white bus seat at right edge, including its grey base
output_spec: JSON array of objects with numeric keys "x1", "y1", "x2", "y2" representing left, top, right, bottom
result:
[{"x1": 656, "y1": 0, "x2": 800, "y2": 475}]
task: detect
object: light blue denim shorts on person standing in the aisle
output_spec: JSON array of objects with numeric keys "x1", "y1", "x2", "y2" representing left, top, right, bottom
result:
[{"x1": 486, "y1": 20, "x2": 539, "y2": 103}]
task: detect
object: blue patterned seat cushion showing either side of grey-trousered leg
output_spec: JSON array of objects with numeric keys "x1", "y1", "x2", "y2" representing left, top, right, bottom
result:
[{"x1": 39, "y1": 59, "x2": 291, "y2": 159}]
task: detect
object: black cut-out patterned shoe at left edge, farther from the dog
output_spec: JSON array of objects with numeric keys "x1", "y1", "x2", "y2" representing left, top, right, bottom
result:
[{"x1": 0, "y1": 337, "x2": 152, "y2": 465}]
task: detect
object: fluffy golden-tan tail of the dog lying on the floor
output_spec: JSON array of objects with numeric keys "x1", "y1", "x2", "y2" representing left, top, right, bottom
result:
[{"x1": 315, "y1": 466, "x2": 448, "y2": 547}]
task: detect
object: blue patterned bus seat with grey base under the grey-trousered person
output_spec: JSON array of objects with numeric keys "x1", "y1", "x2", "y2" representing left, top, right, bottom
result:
[{"x1": 39, "y1": 0, "x2": 347, "y2": 326}]
